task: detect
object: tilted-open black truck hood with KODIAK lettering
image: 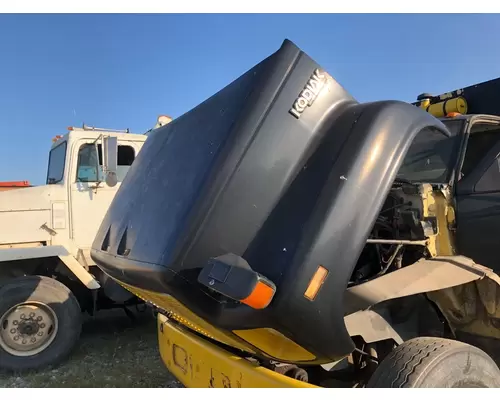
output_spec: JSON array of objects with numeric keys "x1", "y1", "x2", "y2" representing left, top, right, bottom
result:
[{"x1": 92, "y1": 41, "x2": 445, "y2": 361}]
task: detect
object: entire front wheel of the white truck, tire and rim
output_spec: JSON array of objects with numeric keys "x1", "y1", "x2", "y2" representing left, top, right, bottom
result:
[{"x1": 0, "y1": 276, "x2": 82, "y2": 371}]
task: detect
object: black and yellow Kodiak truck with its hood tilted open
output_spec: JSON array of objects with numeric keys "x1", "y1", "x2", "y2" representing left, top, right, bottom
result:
[{"x1": 91, "y1": 41, "x2": 500, "y2": 387}]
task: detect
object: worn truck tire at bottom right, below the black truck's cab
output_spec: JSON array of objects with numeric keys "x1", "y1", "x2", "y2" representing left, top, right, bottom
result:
[{"x1": 367, "y1": 337, "x2": 500, "y2": 388}]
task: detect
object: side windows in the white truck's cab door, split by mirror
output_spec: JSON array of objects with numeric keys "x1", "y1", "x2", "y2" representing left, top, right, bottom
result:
[{"x1": 76, "y1": 143, "x2": 135, "y2": 182}]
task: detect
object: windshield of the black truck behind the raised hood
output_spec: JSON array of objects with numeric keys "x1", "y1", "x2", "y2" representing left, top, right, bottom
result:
[{"x1": 397, "y1": 120, "x2": 463, "y2": 183}]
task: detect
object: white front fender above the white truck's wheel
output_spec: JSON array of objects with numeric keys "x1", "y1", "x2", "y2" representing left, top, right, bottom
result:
[{"x1": 0, "y1": 246, "x2": 101, "y2": 290}]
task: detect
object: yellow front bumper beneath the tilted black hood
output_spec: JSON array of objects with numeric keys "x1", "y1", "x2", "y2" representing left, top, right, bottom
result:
[{"x1": 158, "y1": 314, "x2": 317, "y2": 388}]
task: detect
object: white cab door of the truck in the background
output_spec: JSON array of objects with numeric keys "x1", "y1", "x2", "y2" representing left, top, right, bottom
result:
[{"x1": 70, "y1": 139, "x2": 139, "y2": 262}]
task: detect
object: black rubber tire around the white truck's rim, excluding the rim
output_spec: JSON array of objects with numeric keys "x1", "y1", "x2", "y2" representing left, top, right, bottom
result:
[{"x1": 0, "y1": 276, "x2": 82, "y2": 371}]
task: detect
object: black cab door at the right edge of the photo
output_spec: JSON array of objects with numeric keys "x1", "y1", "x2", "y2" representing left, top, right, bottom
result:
[{"x1": 455, "y1": 124, "x2": 500, "y2": 271}]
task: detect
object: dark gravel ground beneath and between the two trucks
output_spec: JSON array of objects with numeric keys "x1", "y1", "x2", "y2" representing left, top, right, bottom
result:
[{"x1": 0, "y1": 310, "x2": 182, "y2": 388}]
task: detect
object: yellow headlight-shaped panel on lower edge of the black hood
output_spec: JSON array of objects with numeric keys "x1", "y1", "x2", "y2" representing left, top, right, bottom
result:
[{"x1": 233, "y1": 328, "x2": 316, "y2": 362}]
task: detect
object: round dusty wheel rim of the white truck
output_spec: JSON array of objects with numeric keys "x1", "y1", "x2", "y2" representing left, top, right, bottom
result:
[{"x1": 0, "y1": 302, "x2": 58, "y2": 357}]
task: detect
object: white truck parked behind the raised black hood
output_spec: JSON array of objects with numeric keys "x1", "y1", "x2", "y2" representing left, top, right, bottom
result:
[{"x1": 0, "y1": 125, "x2": 155, "y2": 371}]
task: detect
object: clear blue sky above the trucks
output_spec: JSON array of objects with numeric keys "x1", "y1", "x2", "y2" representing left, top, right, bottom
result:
[{"x1": 0, "y1": 15, "x2": 500, "y2": 184}]
